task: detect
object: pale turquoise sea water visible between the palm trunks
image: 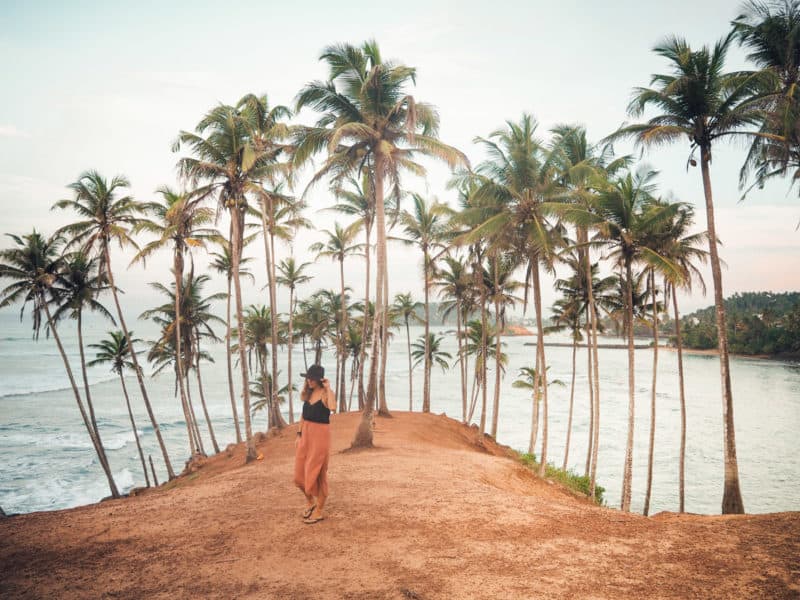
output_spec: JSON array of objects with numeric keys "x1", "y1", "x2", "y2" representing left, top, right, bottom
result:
[{"x1": 0, "y1": 311, "x2": 800, "y2": 513}]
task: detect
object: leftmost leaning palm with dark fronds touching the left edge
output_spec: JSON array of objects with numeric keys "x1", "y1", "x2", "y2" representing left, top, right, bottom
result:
[{"x1": 0, "y1": 229, "x2": 119, "y2": 498}]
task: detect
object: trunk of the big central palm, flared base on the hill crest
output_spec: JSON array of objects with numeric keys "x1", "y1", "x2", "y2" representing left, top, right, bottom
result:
[{"x1": 351, "y1": 153, "x2": 386, "y2": 448}]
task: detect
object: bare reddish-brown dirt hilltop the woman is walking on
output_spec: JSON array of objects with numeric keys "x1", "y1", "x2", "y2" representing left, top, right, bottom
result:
[{"x1": 0, "y1": 413, "x2": 800, "y2": 599}]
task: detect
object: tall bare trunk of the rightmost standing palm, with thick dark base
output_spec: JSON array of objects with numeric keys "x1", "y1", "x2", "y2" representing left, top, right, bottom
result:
[{"x1": 700, "y1": 147, "x2": 744, "y2": 515}]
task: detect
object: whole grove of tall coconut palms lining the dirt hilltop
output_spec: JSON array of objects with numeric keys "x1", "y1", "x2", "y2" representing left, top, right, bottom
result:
[{"x1": 0, "y1": 0, "x2": 800, "y2": 513}]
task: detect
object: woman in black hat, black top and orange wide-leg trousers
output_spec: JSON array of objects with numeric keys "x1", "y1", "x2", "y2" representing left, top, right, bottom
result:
[{"x1": 294, "y1": 365, "x2": 336, "y2": 525}]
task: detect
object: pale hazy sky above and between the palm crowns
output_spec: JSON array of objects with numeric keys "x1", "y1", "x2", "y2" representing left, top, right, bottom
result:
[{"x1": 0, "y1": 0, "x2": 800, "y2": 324}]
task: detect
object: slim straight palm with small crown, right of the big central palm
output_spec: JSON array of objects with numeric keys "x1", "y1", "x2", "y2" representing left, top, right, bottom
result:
[{"x1": 400, "y1": 194, "x2": 448, "y2": 413}]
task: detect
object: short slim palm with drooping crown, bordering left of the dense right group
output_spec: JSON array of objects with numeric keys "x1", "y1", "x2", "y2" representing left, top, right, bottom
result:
[{"x1": 434, "y1": 256, "x2": 474, "y2": 422}]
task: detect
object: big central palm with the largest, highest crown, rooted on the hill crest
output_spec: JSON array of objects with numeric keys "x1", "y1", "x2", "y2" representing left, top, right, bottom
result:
[{"x1": 295, "y1": 41, "x2": 467, "y2": 446}]
